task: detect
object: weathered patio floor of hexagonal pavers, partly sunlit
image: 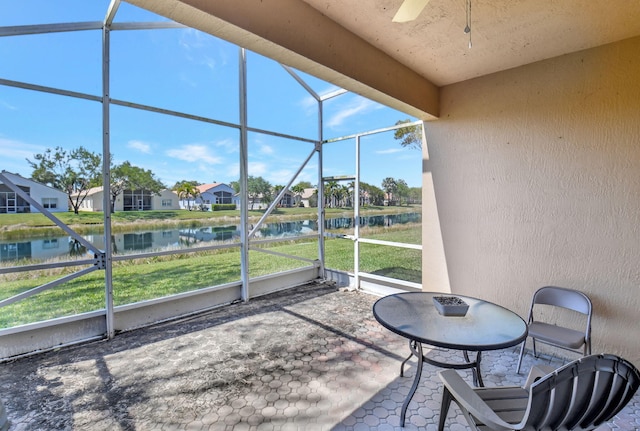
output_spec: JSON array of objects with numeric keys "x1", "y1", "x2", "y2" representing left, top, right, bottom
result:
[{"x1": 0, "y1": 284, "x2": 640, "y2": 431}]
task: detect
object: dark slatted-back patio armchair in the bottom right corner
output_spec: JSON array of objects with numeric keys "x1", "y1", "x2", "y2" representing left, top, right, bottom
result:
[{"x1": 438, "y1": 355, "x2": 640, "y2": 431}]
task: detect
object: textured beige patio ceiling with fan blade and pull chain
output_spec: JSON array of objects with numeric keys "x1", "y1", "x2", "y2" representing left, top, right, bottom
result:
[{"x1": 298, "y1": 0, "x2": 640, "y2": 86}]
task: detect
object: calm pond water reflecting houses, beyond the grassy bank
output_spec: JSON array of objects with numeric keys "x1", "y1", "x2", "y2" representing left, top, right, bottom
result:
[{"x1": 0, "y1": 213, "x2": 421, "y2": 262}]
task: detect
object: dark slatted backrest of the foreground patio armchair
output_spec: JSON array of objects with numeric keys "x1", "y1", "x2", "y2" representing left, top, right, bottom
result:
[{"x1": 522, "y1": 355, "x2": 640, "y2": 430}]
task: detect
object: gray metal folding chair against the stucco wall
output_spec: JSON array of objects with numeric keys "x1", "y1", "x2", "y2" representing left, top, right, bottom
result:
[{"x1": 516, "y1": 286, "x2": 593, "y2": 373}]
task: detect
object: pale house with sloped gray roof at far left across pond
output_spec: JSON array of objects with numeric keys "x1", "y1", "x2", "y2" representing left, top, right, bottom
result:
[{"x1": 0, "y1": 171, "x2": 69, "y2": 214}]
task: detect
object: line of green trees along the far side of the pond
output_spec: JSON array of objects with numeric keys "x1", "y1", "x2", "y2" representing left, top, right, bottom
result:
[{"x1": 27, "y1": 119, "x2": 422, "y2": 214}]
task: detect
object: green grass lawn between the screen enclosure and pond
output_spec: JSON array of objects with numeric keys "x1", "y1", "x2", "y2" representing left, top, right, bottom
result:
[{"x1": 0, "y1": 208, "x2": 422, "y2": 328}]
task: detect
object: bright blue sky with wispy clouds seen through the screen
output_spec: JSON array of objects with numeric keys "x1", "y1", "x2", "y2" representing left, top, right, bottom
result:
[{"x1": 0, "y1": 0, "x2": 421, "y2": 191}]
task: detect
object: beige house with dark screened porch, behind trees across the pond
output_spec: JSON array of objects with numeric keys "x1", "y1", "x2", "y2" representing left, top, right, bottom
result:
[{"x1": 78, "y1": 187, "x2": 180, "y2": 211}]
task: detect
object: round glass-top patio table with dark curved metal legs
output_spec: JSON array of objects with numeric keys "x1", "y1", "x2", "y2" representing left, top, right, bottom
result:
[{"x1": 373, "y1": 292, "x2": 527, "y2": 426}]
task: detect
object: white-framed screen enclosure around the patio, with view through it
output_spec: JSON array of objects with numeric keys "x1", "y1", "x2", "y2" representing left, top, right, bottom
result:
[{"x1": 0, "y1": 0, "x2": 424, "y2": 360}]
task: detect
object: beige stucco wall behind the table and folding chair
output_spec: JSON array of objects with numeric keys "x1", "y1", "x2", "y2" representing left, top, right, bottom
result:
[{"x1": 423, "y1": 38, "x2": 640, "y2": 366}]
